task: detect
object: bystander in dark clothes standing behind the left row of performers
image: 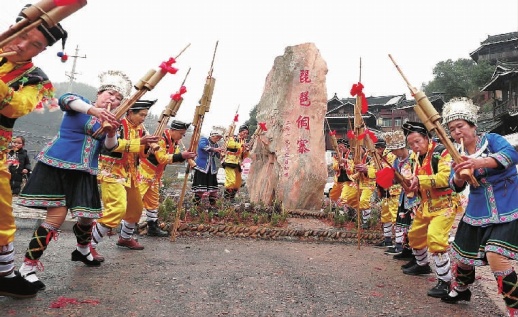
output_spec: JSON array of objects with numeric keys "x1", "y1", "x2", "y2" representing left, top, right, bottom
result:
[{"x1": 7, "y1": 135, "x2": 32, "y2": 195}]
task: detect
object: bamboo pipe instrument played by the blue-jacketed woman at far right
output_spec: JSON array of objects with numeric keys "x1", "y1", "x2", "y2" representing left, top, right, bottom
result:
[{"x1": 389, "y1": 54, "x2": 479, "y2": 187}]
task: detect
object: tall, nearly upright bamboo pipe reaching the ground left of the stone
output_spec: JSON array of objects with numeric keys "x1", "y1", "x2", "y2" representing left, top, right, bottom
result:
[{"x1": 171, "y1": 42, "x2": 218, "y2": 241}]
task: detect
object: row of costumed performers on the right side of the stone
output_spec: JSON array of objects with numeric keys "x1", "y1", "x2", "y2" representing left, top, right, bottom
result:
[{"x1": 329, "y1": 98, "x2": 518, "y2": 316}]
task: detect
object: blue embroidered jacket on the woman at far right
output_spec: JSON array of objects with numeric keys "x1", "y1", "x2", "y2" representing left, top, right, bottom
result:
[{"x1": 450, "y1": 133, "x2": 518, "y2": 226}]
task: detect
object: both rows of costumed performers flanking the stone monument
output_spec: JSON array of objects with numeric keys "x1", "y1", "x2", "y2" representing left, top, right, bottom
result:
[{"x1": 0, "y1": 6, "x2": 518, "y2": 316}]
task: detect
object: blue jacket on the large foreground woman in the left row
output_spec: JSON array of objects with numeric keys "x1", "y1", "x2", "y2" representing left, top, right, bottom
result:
[{"x1": 36, "y1": 93, "x2": 104, "y2": 175}]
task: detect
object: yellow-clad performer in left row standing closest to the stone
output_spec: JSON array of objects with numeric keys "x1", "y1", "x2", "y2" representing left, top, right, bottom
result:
[{"x1": 221, "y1": 125, "x2": 249, "y2": 202}]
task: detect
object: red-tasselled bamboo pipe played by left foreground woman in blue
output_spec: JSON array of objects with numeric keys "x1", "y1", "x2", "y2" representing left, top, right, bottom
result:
[{"x1": 93, "y1": 43, "x2": 191, "y2": 137}]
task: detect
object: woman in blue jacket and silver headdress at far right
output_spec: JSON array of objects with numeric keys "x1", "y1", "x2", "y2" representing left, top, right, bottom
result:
[{"x1": 442, "y1": 98, "x2": 518, "y2": 316}]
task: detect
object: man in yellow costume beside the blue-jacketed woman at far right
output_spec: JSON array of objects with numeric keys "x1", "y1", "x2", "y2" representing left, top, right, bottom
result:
[{"x1": 402, "y1": 122, "x2": 462, "y2": 298}]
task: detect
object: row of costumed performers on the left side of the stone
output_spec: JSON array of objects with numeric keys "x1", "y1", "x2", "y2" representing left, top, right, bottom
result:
[{"x1": 0, "y1": 6, "x2": 256, "y2": 298}]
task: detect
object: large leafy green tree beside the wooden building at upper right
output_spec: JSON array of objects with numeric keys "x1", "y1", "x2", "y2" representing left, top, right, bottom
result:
[{"x1": 424, "y1": 58, "x2": 494, "y2": 101}]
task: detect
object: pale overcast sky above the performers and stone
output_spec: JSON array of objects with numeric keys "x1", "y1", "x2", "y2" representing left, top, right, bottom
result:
[{"x1": 0, "y1": 0, "x2": 518, "y2": 133}]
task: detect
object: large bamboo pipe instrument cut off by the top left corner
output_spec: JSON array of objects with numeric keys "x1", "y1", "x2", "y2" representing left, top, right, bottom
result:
[{"x1": 0, "y1": 0, "x2": 86, "y2": 47}]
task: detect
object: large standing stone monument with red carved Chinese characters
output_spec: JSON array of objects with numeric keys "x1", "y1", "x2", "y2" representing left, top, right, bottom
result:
[{"x1": 247, "y1": 43, "x2": 327, "y2": 210}]
